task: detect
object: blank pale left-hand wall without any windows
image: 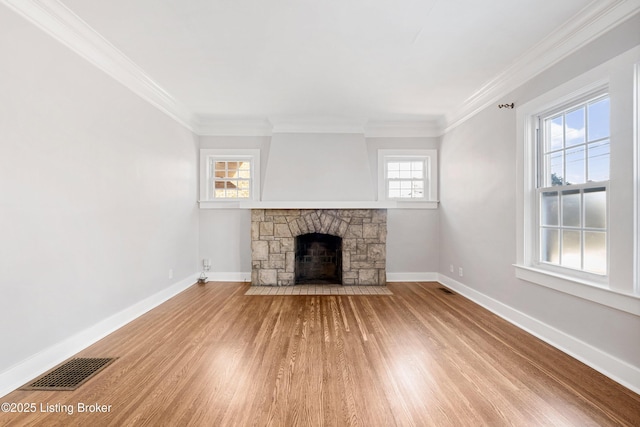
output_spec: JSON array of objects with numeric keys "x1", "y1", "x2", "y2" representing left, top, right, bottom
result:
[{"x1": 0, "y1": 6, "x2": 198, "y2": 382}]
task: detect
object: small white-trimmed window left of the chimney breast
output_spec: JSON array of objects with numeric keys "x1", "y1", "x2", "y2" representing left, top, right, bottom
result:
[{"x1": 200, "y1": 149, "x2": 260, "y2": 202}]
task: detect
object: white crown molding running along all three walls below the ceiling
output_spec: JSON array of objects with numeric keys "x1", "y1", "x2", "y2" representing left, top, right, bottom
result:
[{"x1": 6, "y1": 0, "x2": 640, "y2": 137}]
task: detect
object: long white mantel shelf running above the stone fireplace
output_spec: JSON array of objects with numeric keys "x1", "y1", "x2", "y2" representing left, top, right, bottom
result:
[{"x1": 199, "y1": 200, "x2": 438, "y2": 209}]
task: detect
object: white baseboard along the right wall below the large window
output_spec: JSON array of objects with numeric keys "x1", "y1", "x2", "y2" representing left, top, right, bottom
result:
[{"x1": 438, "y1": 274, "x2": 640, "y2": 394}]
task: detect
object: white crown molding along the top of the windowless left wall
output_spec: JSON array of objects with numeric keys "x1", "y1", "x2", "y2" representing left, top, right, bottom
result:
[{"x1": 0, "y1": 0, "x2": 194, "y2": 131}]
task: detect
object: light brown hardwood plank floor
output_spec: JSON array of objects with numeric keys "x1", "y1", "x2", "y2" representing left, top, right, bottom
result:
[{"x1": 0, "y1": 283, "x2": 640, "y2": 426}]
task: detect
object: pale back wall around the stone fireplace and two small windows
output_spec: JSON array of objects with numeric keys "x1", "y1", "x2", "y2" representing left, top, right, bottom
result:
[{"x1": 199, "y1": 134, "x2": 439, "y2": 280}]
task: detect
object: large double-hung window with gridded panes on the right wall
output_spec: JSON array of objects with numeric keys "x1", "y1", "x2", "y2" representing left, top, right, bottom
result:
[{"x1": 536, "y1": 93, "x2": 610, "y2": 276}]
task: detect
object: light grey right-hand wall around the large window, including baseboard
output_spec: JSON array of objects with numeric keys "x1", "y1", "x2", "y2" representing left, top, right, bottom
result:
[{"x1": 439, "y1": 16, "x2": 640, "y2": 388}]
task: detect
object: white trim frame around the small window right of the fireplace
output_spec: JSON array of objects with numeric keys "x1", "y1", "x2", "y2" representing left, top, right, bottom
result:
[{"x1": 378, "y1": 149, "x2": 438, "y2": 209}]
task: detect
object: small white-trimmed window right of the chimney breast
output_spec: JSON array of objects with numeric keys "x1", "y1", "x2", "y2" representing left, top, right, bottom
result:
[{"x1": 378, "y1": 150, "x2": 438, "y2": 202}]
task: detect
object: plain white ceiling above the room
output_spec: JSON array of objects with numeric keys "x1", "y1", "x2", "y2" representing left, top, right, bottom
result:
[{"x1": 5, "y1": 0, "x2": 637, "y2": 134}]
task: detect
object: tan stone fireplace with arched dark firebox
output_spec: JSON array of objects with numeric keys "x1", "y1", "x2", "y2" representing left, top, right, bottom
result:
[{"x1": 251, "y1": 209, "x2": 387, "y2": 286}]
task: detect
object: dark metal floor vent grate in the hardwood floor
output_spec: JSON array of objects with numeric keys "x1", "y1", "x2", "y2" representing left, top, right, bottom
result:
[{"x1": 20, "y1": 357, "x2": 116, "y2": 390}]
